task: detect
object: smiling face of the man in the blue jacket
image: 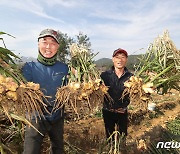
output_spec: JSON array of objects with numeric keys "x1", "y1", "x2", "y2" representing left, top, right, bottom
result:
[{"x1": 38, "y1": 36, "x2": 59, "y2": 58}]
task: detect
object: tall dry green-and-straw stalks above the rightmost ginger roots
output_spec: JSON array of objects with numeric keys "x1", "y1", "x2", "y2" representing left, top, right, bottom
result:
[{"x1": 135, "y1": 31, "x2": 180, "y2": 94}]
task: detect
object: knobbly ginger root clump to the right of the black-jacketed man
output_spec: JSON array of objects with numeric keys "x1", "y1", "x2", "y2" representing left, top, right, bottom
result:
[{"x1": 122, "y1": 76, "x2": 154, "y2": 109}]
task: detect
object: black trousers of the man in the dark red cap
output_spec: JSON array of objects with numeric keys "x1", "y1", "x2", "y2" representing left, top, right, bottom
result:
[{"x1": 102, "y1": 109, "x2": 128, "y2": 138}]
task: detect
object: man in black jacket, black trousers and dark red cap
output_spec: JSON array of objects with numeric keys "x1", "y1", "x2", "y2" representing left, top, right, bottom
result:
[{"x1": 101, "y1": 48, "x2": 132, "y2": 138}]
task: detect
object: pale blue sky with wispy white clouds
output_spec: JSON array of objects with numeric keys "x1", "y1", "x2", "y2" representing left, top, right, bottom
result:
[{"x1": 0, "y1": 0, "x2": 180, "y2": 59}]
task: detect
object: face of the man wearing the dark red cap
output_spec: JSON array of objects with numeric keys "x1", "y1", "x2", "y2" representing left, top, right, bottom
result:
[{"x1": 112, "y1": 53, "x2": 127, "y2": 69}]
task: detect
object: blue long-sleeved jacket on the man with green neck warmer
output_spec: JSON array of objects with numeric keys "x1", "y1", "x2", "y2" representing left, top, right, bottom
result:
[{"x1": 23, "y1": 61, "x2": 68, "y2": 121}]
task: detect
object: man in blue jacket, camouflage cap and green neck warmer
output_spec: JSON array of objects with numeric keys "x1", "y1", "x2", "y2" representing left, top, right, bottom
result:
[{"x1": 23, "y1": 29, "x2": 68, "y2": 154}]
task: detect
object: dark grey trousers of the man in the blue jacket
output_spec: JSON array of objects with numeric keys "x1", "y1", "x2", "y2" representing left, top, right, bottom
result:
[{"x1": 23, "y1": 118, "x2": 64, "y2": 154}]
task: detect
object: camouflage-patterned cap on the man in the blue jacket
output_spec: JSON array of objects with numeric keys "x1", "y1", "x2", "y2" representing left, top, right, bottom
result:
[{"x1": 38, "y1": 29, "x2": 61, "y2": 44}]
